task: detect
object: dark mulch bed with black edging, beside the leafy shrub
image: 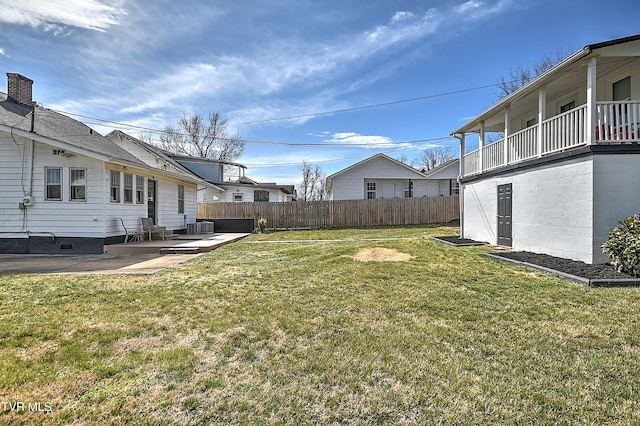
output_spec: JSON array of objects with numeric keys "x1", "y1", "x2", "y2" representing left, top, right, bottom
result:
[{"x1": 484, "y1": 251, "x2": 640, "y2": 286}]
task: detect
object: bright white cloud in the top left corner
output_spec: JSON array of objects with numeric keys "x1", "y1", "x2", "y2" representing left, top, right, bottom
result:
[{"x1": 0, "y1": 0, "x2": 126, "y2": 33}]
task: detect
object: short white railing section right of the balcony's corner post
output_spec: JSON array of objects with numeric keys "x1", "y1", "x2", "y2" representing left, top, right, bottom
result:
[{"x1": 595, "y1": 101, "x2": 640, "y2": 143}]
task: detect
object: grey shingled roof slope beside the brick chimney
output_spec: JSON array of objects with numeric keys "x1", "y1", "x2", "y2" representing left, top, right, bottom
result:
[{"x1": 0, "y1": 92, "x2": 144, "y2": 165}]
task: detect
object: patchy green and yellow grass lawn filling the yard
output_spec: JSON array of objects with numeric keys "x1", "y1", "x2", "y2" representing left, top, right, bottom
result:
[{"x1": 0, "y1": 227, "x2": 640, "y2": 424}]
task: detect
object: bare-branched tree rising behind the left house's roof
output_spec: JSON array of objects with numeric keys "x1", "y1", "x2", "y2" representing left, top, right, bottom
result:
[{"x1": 159, "y1": 111, "x2": 244, "y2": 161}]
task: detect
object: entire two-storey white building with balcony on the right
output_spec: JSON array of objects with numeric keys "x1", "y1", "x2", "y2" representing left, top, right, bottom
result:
[{"x1": 452, "y1": 35, "x2": 640, "y2": 263}]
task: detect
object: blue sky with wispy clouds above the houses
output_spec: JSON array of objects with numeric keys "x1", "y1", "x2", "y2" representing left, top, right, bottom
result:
[{"x1": 0, "y1": 0, "x2": 640, "y2": 184}]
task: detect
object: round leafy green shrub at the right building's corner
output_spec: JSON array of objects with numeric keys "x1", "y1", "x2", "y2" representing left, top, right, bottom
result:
[{"x1": 602, "y1": 214, "x2": 640, "y2": 276}]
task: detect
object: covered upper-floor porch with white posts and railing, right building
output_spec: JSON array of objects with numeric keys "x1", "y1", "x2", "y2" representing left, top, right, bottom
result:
[{"x1": 452, "y1": 36, "x2": 640, "y2": 177}]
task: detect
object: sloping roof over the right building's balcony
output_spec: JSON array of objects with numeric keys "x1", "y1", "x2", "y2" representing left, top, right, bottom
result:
[{"x1": 450, "y1": 34, "x2": 640, "y2": 136}]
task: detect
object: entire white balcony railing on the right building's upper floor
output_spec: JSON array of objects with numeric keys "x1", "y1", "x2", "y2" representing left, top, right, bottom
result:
[{"x1": 463, "y1": 101, "x2": 640, "y2": 176}]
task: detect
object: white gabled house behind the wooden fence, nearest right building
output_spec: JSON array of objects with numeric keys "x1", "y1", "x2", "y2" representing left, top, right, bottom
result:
[{"x1": 327, "y1": 154, "x2": 458, "y2": 200}]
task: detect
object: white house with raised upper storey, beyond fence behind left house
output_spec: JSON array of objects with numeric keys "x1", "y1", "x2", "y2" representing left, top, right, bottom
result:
[{"x1": 167, "y1": 153, "x2": 295, "y2": 203}]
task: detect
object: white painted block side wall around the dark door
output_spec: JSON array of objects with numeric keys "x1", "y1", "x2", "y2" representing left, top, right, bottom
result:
[{"x1": 464, "y1": 157, "x2": 594, "y2": 263}]
